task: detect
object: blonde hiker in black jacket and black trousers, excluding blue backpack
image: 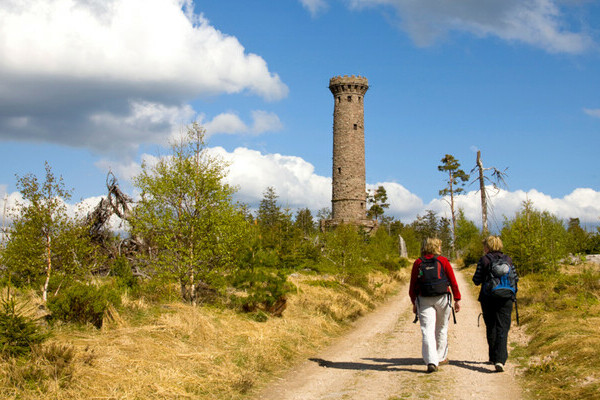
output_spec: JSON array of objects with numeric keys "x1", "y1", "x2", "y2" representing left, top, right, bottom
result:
[{"x1": 473, "y1": 236, "x2": 518, "y2": 372}]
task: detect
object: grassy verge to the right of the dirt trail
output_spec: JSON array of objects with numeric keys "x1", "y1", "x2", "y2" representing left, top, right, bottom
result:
[{"x1": 465, "y1": 263, "x2": 600, "y2": 400}]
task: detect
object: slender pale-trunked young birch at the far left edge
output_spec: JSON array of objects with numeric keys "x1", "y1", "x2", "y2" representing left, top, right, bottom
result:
[{"x1": 1, "y1": 163, "x2": 94, "y2": 299}]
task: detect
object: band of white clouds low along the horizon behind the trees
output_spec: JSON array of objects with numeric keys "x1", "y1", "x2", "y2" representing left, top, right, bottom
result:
[{"x1": 0, "y1": 151, "x2": 600, "y2": 230}]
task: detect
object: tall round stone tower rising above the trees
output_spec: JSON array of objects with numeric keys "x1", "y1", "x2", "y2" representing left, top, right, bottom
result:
[{"x1": 327, "y1": 75, "x2": 376, "y2": 230}]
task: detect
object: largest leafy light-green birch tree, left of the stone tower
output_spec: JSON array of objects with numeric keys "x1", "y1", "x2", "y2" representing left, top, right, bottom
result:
[{"x1": 129, "y1": 123, "x2": 248, "y2": 302}]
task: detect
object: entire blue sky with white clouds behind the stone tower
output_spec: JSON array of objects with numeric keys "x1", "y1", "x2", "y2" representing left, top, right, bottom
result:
[{"x1": 0, "y1": 0, "x2": 600, "y2": 231}]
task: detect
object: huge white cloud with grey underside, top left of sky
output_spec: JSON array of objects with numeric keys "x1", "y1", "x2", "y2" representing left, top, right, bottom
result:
[{"x1": 0, "y1": 0, "x2": 288, "y2": 152}]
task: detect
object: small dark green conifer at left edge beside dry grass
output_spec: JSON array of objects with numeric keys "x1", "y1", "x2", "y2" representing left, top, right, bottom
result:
[{"x1": 0, "y1": 294, "x2": 48, "y2": 357}]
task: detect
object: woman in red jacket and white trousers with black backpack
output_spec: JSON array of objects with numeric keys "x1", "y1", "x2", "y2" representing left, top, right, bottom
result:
[{"x1": 409, "y1": 238, "x2": 460, "y2": 372}]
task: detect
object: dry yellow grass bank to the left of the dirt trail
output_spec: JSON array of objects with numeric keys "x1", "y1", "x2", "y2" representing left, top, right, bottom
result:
[{"x1": 0, "y1": 272, "x2": 407, "y2": 400}]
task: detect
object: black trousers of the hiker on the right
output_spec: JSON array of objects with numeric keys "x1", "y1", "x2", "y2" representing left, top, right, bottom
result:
[{"x1": 481, "y1": 298, "x2": 513, "y2": 364}]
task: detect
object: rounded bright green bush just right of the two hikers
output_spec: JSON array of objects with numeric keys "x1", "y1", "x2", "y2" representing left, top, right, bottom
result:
[{"x1": 502, "y1": 201, "x2": 567, "y2": 275}]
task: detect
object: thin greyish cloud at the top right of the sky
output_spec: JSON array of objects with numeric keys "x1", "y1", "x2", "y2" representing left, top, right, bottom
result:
[{"x1": 350, "y1": 0, "x2": 592, "y2": 54}]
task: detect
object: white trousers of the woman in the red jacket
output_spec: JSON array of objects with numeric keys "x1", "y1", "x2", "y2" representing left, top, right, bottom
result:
[{"x1": 417, "y1": 295, "x2": 452, "y2": 365}]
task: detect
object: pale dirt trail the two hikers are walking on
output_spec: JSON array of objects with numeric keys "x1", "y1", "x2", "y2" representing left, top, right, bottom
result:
[{"x1": 255, "y1": 271, "x2": 522, "y2": 400}]
